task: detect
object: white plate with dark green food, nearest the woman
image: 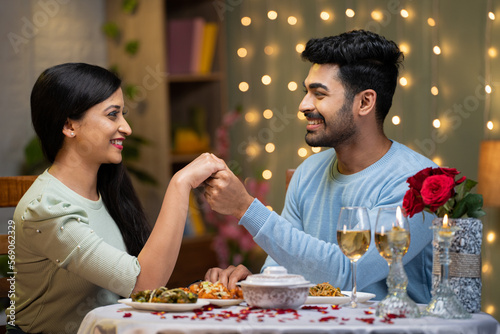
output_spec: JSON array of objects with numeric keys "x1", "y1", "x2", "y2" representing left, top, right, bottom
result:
[{"x1": 118, "y1": 287, "x2": 209, "y2": 312}]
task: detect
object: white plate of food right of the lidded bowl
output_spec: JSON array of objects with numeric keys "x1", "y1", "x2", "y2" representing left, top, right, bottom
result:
[{"x1": 305, "y1": 282, "x2": 375, "y2": 305}]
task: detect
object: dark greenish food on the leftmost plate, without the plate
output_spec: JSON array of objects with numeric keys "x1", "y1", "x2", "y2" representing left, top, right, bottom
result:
[{"x1": 130, "y1": 287, "x2": 198, "y2": 304}]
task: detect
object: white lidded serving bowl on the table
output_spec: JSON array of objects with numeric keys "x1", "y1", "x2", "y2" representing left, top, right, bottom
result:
[{"x1": 238, "y1": 266, "x2": 313, "y2": 309}]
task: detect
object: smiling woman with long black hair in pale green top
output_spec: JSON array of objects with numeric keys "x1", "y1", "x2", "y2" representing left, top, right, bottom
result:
[{"x1": 11, "y1": 63, "x2": 225, "y2": 333}]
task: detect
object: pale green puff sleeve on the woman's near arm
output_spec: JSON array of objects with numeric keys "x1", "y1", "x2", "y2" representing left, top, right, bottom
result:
[{"x1": 20, "y1": 194, "x2": 140, "y2": 296}]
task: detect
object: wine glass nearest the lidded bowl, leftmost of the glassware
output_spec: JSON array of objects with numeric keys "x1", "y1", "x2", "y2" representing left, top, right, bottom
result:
[{"x1": 337, "y1": 207, "x2": 371, "y2": 308}]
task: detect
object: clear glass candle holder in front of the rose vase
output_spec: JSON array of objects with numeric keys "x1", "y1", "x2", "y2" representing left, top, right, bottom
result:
[{"x1": 424, "y1": 226, "x2": 471, "y2": 319}]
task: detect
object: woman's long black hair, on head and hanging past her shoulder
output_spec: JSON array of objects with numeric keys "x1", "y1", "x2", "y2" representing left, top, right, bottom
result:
[{"x1": 31, "y1": 63, "x2": 151, "y2": 256}]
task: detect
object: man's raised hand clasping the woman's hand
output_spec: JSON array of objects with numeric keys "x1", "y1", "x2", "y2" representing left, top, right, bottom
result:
[{"x1": 204, "y1": 166, "x2": 254, "y2": 220}]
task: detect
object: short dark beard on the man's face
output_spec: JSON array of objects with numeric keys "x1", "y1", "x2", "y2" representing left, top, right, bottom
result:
[{"x1": 305, "y1": 99, "x2": 356, "y2": 148}]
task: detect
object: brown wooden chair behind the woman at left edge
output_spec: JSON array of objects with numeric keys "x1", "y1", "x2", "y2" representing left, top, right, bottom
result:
[{"x1": 0, "y1": 175, "x2": 37, "y2": 334}]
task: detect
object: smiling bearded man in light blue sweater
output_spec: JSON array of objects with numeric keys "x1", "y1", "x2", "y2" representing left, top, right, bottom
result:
[{"x1": 205, "y1": 30, "x2": 436, "y2": 303}]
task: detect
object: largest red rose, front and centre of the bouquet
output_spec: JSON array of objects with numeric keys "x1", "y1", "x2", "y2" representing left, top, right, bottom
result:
[{"x1": 420, "y1": 174, "x2": 455, "y2": 212}]
